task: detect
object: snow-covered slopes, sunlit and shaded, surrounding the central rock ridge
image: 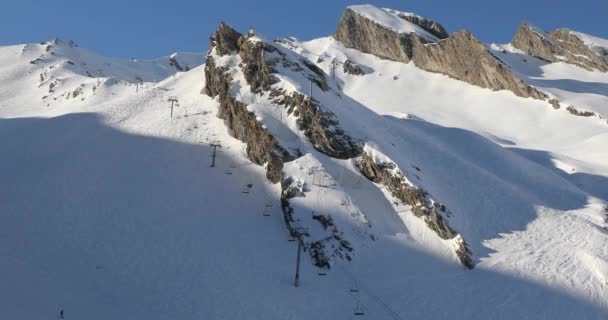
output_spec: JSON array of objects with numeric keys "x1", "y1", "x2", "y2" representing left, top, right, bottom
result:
[{"x1": 0, "y1": 7, "x2": 608, "y2": 319}]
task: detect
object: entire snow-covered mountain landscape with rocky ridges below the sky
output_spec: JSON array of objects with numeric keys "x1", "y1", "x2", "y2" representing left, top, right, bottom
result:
[{"x1": 0, "y1": 5, "x2": 608, "y2": 319}]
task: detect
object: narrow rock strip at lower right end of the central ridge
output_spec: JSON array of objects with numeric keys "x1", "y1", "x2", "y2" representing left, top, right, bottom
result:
[{"x1": 357, "y1": 153, "x2": 475, "y2": 269}]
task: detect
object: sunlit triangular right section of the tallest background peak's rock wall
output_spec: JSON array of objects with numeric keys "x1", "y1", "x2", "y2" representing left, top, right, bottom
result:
[{"x1": 413, "y1": 30, "x2": 547, "y2": 99}]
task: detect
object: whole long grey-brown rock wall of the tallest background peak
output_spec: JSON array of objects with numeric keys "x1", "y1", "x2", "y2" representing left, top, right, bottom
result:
[{"x1": 334, "y1": 9, "x2": 547, "y2": 100}]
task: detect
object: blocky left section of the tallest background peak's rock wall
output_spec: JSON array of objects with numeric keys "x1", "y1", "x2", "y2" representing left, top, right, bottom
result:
[{"x1": 334, "y1": 9, "x2": 411, "y2": 62}]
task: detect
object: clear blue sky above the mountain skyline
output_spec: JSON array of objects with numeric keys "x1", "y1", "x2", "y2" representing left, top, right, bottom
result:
[{"x1": 0, "y1": 0, "x2": 608, "y2": 58}]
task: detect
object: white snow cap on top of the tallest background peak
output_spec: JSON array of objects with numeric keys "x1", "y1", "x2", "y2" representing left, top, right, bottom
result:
[{"x1": 348, "y1": 4, "x2": 439, "y2": 42}]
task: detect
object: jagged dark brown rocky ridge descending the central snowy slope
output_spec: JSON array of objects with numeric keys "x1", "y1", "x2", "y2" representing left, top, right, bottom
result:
[{"x1": 204, "y1": 23, "x2": 473, "y2": 268}]
